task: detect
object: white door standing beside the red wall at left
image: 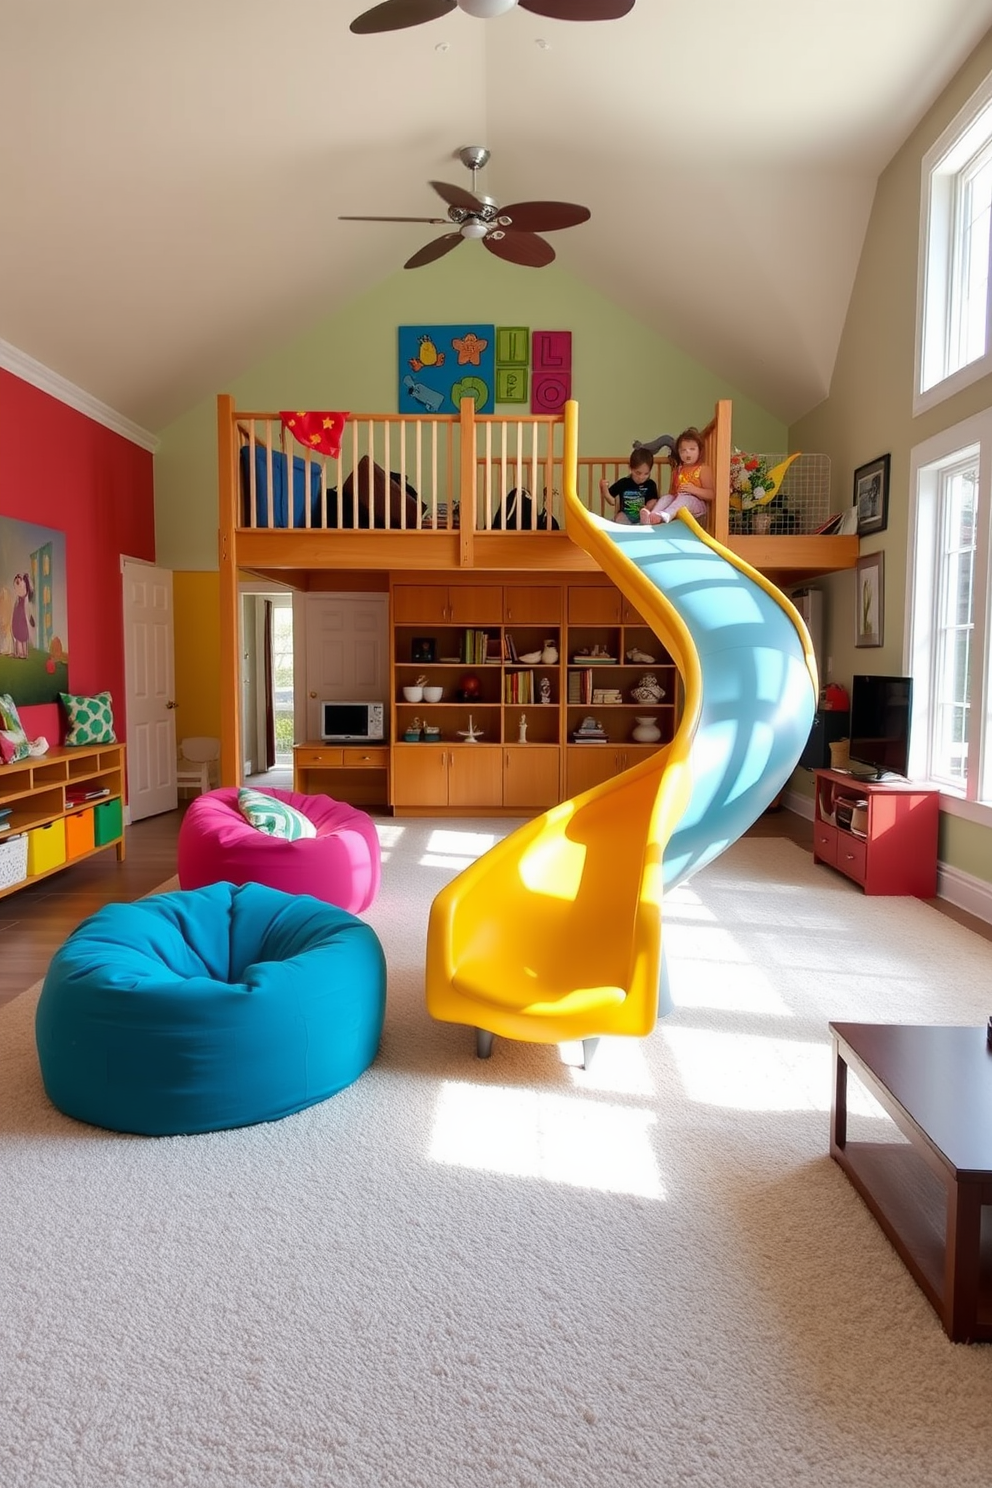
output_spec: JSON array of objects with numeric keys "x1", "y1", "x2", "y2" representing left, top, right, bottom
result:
[{"x1": 122, "y1": 558, "x2": 178, "y2": 821}]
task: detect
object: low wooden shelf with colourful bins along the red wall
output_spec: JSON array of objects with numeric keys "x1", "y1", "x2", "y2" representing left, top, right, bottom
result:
[{"x1": 0, "y1": 744, "x2": 125, "y2": 896}]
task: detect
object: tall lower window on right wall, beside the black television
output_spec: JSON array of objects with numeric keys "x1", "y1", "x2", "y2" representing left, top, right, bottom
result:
[{"x1": 910, "y1": 411, "x2": 992, "y2": 820}]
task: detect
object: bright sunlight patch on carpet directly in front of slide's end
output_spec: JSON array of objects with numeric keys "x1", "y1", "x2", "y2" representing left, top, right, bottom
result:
[{"x1": 428, "y1": 1080, "x2": 665, "y2": 1199}]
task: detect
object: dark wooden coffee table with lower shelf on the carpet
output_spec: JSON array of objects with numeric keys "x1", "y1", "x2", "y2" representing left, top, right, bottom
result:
[{"x1": 830, "y1": 1022, "x2": 992, "y2": 1342}]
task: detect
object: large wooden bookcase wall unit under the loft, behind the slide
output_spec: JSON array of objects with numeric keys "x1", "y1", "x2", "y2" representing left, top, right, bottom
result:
[{"x1": 390, "y1": 573, "x2": 681, "y2": 815}]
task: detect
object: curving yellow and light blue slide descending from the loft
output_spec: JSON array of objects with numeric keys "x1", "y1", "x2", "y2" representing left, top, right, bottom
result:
[{"x1": 427, "y1": 414, "x2": 817, "y2": 1055}]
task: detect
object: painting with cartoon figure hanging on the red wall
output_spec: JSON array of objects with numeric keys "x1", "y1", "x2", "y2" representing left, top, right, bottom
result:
[{"x1": 0, "y1": 516, "x2": 68, "y2": 707}]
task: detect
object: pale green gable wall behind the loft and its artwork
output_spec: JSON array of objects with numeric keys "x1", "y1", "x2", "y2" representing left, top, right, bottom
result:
[{"x1": 155, "y1": 255, "x2": 785, "y2": 570}]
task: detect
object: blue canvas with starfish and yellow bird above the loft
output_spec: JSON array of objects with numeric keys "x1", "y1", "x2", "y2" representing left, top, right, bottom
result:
[{"x1": 397, "y1": 326, "x2": 495, "y2": 415}]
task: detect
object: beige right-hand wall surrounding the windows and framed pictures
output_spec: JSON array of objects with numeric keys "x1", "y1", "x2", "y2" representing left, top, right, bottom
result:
[{"x1": 788, "y1": 33, "x2": 992, "y2": 881}]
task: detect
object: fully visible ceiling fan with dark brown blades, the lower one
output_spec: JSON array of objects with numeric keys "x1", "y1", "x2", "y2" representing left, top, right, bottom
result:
[{"x1": 338, "y1": 149, "x2": 592, "y2": 269}]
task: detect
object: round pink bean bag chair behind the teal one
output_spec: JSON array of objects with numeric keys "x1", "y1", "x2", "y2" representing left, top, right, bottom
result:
[{"x1": 178, "y1": 786, "x2": 381, "y2": 915}]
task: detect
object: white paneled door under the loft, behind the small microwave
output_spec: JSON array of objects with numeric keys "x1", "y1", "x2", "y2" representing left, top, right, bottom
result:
[{"x1": 303, "y1": 594, "x2": 390, "y2": 740}]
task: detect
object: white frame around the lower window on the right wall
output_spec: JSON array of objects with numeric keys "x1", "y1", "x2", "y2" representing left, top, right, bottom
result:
[{"x1": 904, "y1": 409, "x2": 992, "y2": 827}]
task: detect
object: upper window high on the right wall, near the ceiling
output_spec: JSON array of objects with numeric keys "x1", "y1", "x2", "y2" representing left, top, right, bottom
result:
[{"x1": 913, "y1": 77, "x2": 992, "y2": 414}]
